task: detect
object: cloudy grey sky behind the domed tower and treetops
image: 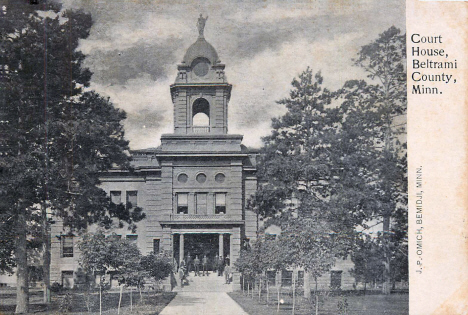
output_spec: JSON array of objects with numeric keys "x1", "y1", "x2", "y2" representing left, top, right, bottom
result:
[{"x1": 62, "y1": 0, "x2": 405, "y2": 149}]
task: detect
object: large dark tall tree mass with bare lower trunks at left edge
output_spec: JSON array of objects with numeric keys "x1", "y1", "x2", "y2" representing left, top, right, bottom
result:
[{"x1": 0, "y1": 0, "x2": 144, "y2": 313}]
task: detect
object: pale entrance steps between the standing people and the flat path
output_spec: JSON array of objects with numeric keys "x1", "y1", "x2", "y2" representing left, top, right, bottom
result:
[{"x1": 173, "y1": 271, "x2": 233, "y2": 292}]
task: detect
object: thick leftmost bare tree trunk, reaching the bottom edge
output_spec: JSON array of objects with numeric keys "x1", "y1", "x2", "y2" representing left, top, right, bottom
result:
[{"x1": 15, "y1": 206, "x2": 29, "y2": 314}]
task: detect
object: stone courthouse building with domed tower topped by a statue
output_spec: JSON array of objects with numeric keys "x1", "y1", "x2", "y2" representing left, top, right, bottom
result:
[{"x1": 51, "y1": 20, "x2": 258, "y2": 285}]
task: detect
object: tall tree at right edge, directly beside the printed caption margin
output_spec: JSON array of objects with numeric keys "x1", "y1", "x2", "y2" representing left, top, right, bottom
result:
[{"x1": 339, "y1": 27, "x2": 407, "y2": 294}]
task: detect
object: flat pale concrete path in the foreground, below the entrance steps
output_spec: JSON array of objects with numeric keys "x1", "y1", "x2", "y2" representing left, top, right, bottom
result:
[{"x1": 160, "y1": 292, "x2": 248, "y2": 315}]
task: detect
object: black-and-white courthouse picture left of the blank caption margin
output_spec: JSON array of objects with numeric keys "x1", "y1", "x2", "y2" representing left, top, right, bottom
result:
[{"x1": 9, "y1": 0, "x2": 461, "y2": 315}]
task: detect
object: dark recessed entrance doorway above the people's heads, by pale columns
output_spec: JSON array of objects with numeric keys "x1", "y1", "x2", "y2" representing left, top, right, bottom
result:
[{"x1": 173, "y1": 233, "x2": 231, "y2": 271}]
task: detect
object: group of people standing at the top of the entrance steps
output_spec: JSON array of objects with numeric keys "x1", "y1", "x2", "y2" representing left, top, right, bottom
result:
[{"x1": 179, "y1": 254, "x2": 232, "y2": 285}]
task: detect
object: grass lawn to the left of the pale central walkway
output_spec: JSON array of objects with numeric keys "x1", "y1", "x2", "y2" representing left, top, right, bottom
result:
[{"x1": 0, "y1": 290, "x2": 176, "y2": 315}]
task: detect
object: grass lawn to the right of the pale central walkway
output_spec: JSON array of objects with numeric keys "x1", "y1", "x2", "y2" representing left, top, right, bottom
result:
[{"x1": 229, "y1": 291, "x2": 409, "y2": 315}]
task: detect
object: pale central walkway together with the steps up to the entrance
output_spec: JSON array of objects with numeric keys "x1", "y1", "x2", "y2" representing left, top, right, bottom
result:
[{"x1": 160, "y1": 273, "x2": 248, "y2": 315}]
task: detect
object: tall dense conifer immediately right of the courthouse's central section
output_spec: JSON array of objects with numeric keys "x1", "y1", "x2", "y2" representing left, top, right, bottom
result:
[{"x1": 258, "y1": 68, "x2": 340, "y2": 222}]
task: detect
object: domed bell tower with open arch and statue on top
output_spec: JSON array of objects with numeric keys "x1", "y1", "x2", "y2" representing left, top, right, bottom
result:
[{"x1": 170, "y1": 14, "x2": 232, "y2": 135}]
